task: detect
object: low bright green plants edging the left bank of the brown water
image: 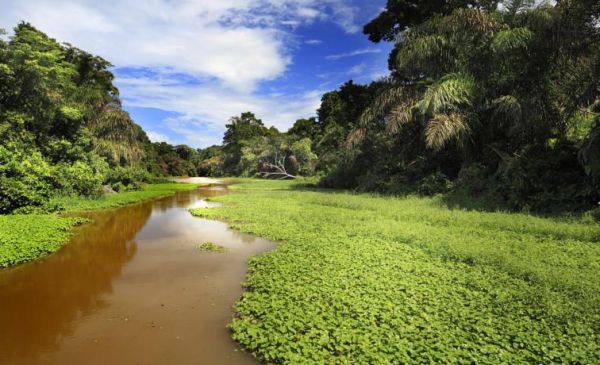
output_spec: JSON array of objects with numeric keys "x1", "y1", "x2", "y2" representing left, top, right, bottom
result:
[{"x1": 0, "y1": 184, "x2": 197, "y2": 268}]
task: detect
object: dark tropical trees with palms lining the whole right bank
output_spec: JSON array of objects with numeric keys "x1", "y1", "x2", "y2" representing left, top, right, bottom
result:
[{"x1": 202, "y1": 0, "x2": 600, "y2": 211}]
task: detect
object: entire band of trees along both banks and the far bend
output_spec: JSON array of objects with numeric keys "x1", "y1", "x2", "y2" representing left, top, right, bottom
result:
[{"x1": 0, "y1": 0, "x2": 600, "y2": 213}]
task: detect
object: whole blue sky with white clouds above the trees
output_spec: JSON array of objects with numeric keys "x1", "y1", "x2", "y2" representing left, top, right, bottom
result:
[{"x1": 0, "y1": 0, "x2": 391, "y2": 148}]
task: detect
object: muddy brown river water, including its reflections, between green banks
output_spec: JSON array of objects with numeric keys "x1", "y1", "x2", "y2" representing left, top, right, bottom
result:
[{"x1": 0, "y1": 188, "x2": 274, "y2": 365}]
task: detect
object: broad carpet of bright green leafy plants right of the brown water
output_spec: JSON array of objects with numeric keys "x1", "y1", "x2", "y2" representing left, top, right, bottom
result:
[{"x1": 193, "y1": 180, "x2": 600, "y2": 364}]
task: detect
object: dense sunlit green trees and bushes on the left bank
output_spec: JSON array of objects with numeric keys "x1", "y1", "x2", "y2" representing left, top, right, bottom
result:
[{"x1": 0, "y1": 23, "x2": 204, "y2": 214}]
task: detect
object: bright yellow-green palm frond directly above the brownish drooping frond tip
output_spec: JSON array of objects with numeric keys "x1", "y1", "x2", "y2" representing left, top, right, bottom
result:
[{"x1": 419, "y1": 73, "x2": 475, "y2": 114}]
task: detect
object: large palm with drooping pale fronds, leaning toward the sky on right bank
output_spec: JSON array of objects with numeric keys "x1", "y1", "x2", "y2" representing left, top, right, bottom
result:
[{"x1": 348, "y1": 6, "x2": 537, "y2": 151}]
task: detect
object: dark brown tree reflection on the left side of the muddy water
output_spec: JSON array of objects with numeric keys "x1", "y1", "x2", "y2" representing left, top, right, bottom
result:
[{"x1": 0, "y1": 203, "x2": 152, "y2": 364}]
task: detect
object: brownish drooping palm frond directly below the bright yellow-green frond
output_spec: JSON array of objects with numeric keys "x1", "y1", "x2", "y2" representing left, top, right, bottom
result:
[{"x1": 425, "y1": 113, "x2": 469, "y2": 151}]
